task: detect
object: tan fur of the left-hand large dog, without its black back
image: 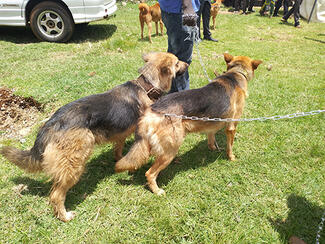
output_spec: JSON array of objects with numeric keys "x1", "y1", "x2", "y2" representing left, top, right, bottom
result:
[{"x1": 0, "y1": 53, "x2": 188, "y2": 222}]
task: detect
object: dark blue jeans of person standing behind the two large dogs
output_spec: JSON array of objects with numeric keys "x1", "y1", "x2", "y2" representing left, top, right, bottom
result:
[{"x1": 161, "y1": 11, "x2": 193, "y2": 93}]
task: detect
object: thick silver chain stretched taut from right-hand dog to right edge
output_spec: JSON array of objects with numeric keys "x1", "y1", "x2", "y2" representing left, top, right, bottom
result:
[{"x1": 164, "y1": 110, "x2": 325, "y2": 122}]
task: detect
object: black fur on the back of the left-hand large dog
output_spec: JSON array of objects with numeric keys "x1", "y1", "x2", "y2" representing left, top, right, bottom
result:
[{"x1": 31, "y1": 82, "x2": 141, "y2": 160}]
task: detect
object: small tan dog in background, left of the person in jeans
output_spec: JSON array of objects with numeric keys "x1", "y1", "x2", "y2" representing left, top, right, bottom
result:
[{"x1": 139, "y1": 3, "x2": 164, "y2": 43}]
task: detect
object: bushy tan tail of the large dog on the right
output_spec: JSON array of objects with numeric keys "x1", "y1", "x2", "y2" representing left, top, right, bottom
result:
[{"x1": 115, "y1": 139, "x2": 150, "y2": 172}]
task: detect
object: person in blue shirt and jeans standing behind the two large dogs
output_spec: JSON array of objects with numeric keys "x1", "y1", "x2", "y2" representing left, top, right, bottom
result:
[{"x1": 158, "y1": 0, "x2": 200, "y2": 93}]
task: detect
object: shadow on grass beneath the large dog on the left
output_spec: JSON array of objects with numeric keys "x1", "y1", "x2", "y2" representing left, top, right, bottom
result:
[{"x1": 13, "y1": 146, "x2": 115, "y2": 210}]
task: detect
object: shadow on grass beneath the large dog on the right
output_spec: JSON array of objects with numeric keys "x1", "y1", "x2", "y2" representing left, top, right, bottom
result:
[{"x1": 119, "y1": 132, "x2": 227, "y2": 190}]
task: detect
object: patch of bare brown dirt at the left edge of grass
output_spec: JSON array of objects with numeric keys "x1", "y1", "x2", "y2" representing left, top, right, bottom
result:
[{"x1": 0, "y1": 87, "x2": 43, "y2": 138}]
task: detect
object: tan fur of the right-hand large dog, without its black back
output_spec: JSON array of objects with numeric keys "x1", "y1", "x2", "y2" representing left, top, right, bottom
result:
[{"x1": 115, "y1": 54, "x2": 262, "y2": 195}]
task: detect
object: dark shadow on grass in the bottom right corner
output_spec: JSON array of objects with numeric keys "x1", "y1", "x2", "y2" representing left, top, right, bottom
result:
[{"x1": 269, "y1": 194, "x2": 325, "y2": 243}]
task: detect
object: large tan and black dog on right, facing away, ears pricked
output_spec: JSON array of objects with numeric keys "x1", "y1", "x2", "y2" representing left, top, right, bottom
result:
[{"x1": 115, "y1": 53, "x2": 262, "y2": 195}]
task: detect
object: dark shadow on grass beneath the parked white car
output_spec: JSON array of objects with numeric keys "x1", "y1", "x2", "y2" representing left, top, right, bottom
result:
[{"x1": 0, "y1": 24, "x2": 117, "y2": 44}]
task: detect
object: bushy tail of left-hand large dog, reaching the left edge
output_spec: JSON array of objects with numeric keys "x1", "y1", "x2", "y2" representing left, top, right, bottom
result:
[{"x1": 0, "y1": 147, "x2": 42, "y2": 173}]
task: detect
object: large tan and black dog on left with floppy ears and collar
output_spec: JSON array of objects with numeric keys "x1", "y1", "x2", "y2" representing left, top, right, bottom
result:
[{"x1": 0, "y1": 53, "x2": 188, "y2": 221}]
